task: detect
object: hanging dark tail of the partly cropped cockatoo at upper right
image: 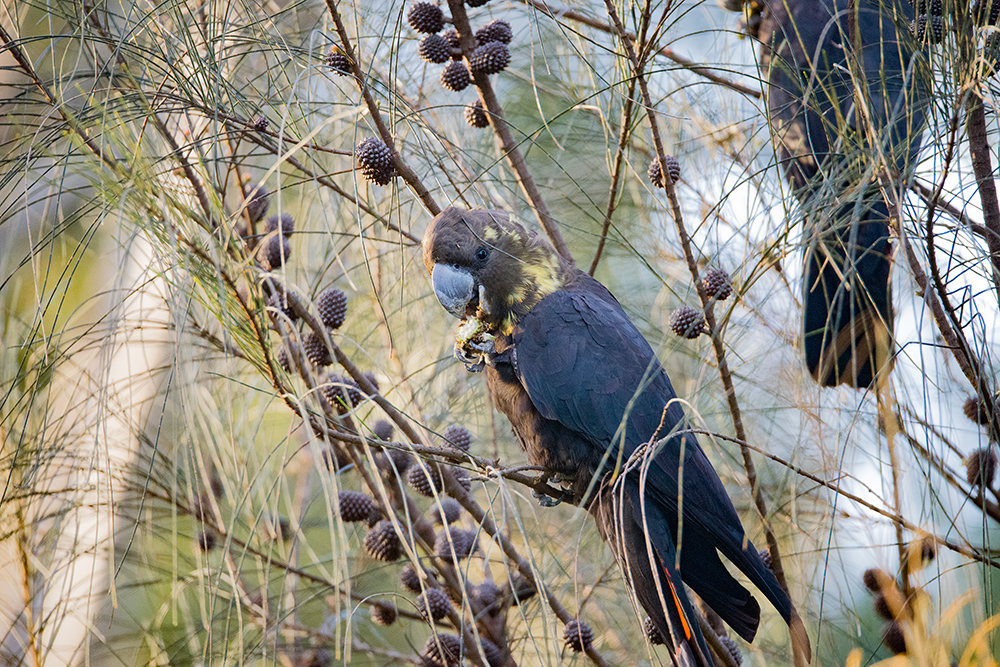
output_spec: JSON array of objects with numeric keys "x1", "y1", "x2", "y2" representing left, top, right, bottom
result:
[{"x1": 803, "y1": 200, "x2": 892, "y2": 388}]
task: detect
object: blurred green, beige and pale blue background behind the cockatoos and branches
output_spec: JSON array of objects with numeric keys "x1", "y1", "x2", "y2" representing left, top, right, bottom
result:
[{"x1": 0, "y1": 0, "x2": 1000, "y2": 666}]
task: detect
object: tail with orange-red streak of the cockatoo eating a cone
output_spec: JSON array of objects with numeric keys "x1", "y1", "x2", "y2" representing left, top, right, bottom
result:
[{"x1": 590, "y1": 478, "x2": 714, "y2": 667}]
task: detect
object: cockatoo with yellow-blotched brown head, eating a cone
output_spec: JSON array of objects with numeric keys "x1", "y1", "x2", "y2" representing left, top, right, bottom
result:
[{"x1": 423, "y1": 208, "x2": 808, "y2": 665}]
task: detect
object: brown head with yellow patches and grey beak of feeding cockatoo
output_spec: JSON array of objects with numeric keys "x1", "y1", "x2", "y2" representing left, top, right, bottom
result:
[{"x1": 424, "y1": 208, "x2": 569, "y2": 333}]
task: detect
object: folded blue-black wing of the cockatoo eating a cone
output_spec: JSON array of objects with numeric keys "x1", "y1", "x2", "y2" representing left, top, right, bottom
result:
[{"x1": 513, "y1": 280, "x2": 791, "y2": 636}]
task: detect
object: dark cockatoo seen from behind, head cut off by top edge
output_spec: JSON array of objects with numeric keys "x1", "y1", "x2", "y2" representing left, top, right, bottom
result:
[{"x1": 752, "y1": 0, "x2": 926, "y2": 388}]
